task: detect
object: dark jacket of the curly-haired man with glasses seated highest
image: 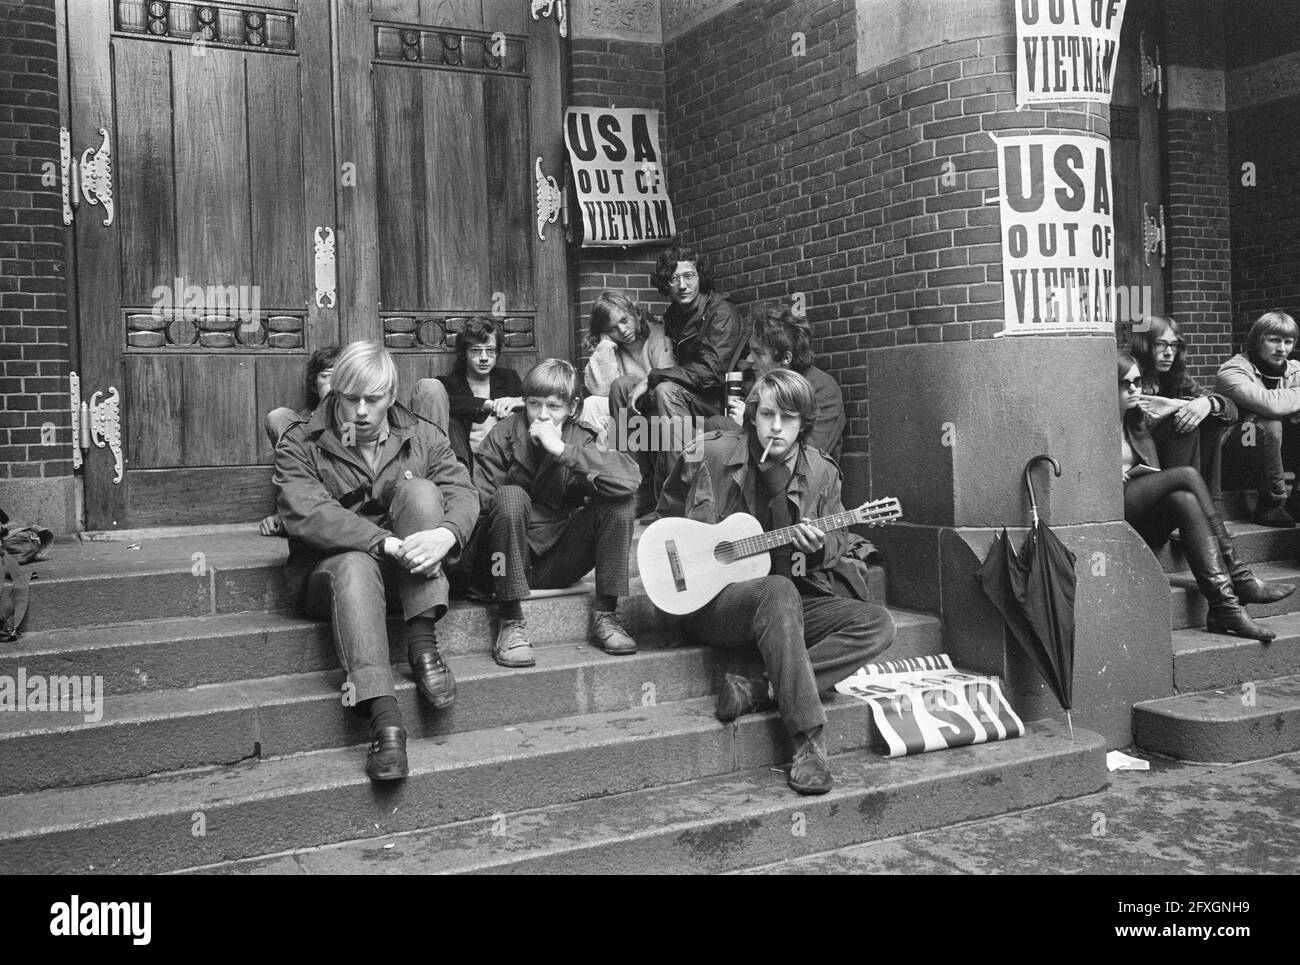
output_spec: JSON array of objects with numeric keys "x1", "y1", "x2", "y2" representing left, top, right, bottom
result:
[{"x1": 646, "y1": 291, "x2": 749, "y2": 407}]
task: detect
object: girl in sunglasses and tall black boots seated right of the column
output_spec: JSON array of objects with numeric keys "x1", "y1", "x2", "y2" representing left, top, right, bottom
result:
[{"x1": 1117, "y1": 351, "x2": 1295, "y2": 642}]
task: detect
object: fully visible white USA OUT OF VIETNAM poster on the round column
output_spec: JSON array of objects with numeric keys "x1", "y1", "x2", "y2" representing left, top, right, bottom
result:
[{"x1": 996, "y1": 134, "x2": 1115, "y2": 336}]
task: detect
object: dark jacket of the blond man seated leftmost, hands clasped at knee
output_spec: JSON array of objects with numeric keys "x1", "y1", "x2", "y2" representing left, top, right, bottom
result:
[{"x1": 274, "y1": 395, "x2": 478, "y2": 600}]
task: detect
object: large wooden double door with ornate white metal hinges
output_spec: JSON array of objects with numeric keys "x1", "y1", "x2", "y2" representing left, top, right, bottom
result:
[{"x1": 61, "y1": 0, "x2": 572, "y2": 529}]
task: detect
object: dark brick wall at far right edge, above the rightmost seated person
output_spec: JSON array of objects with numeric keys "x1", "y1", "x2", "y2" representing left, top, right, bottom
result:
[{"x1": 1229, "y1": 95, "x2": 1300, "y2": 342}]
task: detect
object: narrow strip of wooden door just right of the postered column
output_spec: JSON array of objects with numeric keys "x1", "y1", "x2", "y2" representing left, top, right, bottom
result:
[{"x1": 1110, "y1": 3, "x2": 1167, "y2": 330}]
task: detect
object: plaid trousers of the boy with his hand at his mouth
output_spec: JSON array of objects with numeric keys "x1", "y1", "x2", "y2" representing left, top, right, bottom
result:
[{"x1": 475, "y1": 485, "x2": 636, "y2": 601}]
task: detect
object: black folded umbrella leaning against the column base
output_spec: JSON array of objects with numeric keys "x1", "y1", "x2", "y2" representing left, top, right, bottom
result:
[{"x1": 978, "y1": 455, "x2": 1075, "y2": 737}]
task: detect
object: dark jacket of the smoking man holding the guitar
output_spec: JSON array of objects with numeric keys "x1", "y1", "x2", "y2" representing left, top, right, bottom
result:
[{"x1": 658, "y1": 429, "x2": 874, "y2": 600}]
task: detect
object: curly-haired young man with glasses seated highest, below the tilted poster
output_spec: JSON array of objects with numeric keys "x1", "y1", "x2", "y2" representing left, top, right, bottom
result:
[{"x1": 610, "y1": 243, "x2": 746, "y2": 514}]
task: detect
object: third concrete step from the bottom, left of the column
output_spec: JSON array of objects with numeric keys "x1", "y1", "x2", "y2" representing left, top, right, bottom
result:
[{"x1": 0, "y1": 610, "x2": 943, "y2": 795}]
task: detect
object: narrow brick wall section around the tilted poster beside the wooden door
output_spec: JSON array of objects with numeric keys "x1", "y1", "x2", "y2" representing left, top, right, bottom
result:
[{"x1": 569, "y1": 39, "x2": 680, "y2": 356}]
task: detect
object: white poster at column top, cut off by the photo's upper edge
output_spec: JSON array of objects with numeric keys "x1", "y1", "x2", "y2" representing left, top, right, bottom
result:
[{"x1": 1014, "y1": 0, "x2": 1127, "y2": 107}]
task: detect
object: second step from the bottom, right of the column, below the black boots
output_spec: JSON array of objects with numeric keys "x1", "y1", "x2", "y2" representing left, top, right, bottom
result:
[{"x1": 1173, "y1": 616, "x2": 1300, "y2": 693}]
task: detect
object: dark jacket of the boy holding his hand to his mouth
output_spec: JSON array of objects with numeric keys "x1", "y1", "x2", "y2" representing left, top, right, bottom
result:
[{"x1": 475, "y1": 410, "x2": 641, "y2": 553}]
